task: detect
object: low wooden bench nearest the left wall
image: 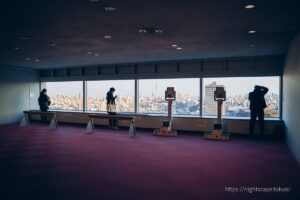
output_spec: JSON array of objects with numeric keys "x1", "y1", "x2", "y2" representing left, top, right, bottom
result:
[{"x1": 20, "y1": 110, "x2": 58, "y2": 129}]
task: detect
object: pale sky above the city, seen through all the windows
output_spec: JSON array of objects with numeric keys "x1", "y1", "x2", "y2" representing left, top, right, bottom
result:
[{"x1": 42, "y1": 77, "x2": 280, "y2": 96}]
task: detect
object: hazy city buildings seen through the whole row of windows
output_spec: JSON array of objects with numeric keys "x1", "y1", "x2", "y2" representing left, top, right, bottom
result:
[{"x1": 50, "y1": 82, "x2": 280, "y2": 118}]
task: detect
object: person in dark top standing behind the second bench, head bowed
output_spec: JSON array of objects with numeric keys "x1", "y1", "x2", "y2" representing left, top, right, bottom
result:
[{"x1": 106, "y1": 87, "x2": 118, "y2": 129}]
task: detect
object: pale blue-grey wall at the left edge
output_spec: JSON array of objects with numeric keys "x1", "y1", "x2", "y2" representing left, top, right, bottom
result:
[{"x1": 0, "y1": 66, "x2": 39, "y2": 124}]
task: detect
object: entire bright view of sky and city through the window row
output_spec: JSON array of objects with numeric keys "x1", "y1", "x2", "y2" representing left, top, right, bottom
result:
[{"x1": 43, "y1": 77, "x2": 280, "y2": 117}]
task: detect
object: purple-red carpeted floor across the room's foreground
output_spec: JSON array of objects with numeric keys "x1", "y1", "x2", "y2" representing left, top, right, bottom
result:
[{"x1": 0, "y1": 124, "x2": 300, "y2": 200}]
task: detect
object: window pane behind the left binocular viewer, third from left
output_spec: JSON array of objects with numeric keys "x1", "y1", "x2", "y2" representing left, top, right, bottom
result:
[{"x1": 138, "y1": 78, "x2": 200, "y2": 115}]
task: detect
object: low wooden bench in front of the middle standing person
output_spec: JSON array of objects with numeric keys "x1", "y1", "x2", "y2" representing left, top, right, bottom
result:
[{"x1": 86, "y1": 114, "x2": 136, "y2": 137}]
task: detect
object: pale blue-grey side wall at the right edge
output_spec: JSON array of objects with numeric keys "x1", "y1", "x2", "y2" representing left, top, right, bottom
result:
[{"x1": 283, "y1": 32, "x2": 300, "y2": 163}]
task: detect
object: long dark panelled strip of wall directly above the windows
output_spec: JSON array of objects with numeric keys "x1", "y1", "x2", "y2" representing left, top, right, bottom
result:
[{"x1": 40, "y1": 56, "x2": 284, "y2": 81}]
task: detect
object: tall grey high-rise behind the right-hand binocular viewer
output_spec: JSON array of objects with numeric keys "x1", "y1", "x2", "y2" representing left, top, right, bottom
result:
[{"x1": 203, "y1": 82, "x2": 226, "y2": 116}]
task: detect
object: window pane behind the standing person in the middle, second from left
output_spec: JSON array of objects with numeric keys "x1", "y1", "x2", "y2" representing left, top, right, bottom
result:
[{"x1": 87, "y1": 80, "x2": 134, "y2": 112}]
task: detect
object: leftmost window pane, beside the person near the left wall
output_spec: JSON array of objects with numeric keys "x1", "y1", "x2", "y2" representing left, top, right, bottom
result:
[{"x1": 42, "y1": 81, "x2": 83, "y2": 110}]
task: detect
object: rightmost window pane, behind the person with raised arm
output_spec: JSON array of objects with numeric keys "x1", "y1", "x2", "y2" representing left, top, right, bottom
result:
[{"x1": 203, "y1": 76, "x2": 280, "y2": 118}]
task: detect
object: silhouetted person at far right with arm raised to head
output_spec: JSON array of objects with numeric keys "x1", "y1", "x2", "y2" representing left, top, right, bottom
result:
[{"x1": 249, "y1": 85, "x2": 269, "y2": 135}]
